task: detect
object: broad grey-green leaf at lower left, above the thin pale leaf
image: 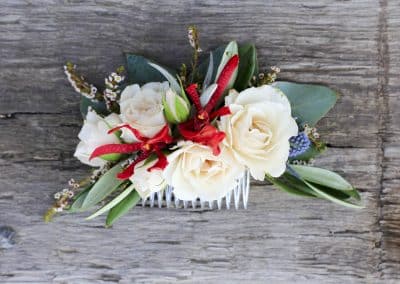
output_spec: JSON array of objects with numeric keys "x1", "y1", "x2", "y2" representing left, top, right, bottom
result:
[{"x1": 82, "y1": 162, "x2": 125, "y2": 209}]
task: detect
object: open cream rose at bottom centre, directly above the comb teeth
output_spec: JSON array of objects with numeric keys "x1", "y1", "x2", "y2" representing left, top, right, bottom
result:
[{"x1": 164, "y1": 141, "x2": 244, "y2": 201}]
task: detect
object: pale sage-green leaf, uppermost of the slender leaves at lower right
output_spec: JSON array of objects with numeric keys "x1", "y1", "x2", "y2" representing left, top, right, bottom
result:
[{"x1": 291, "y1": 165, "x2": 353, "y2": 190}]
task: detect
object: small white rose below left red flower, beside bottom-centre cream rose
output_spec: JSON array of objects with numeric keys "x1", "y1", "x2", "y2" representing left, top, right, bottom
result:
[{"x1": 129, "y1": 160, "x2": 166, "y2": 199}]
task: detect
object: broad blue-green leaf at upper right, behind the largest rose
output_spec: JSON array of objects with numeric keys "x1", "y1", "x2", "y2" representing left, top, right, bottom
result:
[{"x1": 273, "y1": 81, "x2": 338, "y2": 126}]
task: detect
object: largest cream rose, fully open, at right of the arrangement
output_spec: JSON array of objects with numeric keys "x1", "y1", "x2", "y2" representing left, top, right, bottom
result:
[{"x1": 218, "y1": 85, "x2": 298, "y2": 180}]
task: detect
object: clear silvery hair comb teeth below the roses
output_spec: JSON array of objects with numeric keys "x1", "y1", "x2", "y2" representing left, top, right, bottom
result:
[{"x1": 140, "y1": 170, "x2": 250, "y2": 209}]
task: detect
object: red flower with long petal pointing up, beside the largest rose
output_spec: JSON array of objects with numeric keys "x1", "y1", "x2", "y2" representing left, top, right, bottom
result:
[{"x1": 178, "y1": 55, "x2": 239, "y2": 155}]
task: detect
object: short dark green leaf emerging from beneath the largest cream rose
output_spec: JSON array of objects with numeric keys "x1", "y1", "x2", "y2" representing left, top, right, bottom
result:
[{"x1": 265, "y1": 173, "x2": 317, "y2": 197}]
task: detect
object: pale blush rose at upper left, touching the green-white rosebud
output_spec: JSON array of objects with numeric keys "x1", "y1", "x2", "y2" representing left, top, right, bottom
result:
[{"x1": 119, "y1": 82, "x2": 169, "y2": 143}]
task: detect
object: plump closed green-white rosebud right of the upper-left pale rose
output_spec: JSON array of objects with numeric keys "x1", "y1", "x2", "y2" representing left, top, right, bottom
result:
[{"x1": 162, "y1": 89, "x2": 190, "y2": 124}]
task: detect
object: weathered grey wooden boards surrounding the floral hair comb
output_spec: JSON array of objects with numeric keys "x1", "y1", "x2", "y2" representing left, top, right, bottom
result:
[{"x1": 0, "y1": 0, "x2": 400, "y2": 283}]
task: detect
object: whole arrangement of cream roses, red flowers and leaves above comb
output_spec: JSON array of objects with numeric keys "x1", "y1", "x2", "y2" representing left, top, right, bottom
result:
[{"x1": 45, "y1": 26, "x2": 362, "y2": 226}]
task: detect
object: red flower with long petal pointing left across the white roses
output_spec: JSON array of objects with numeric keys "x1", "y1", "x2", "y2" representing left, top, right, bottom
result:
[{"x1": 90, "y1": 124, "x2": 173, "y2": 179}]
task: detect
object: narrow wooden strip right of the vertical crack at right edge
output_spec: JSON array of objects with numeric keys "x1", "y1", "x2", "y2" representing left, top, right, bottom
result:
[{"x1": 379, "y1": 1, "x2": 400, "y2": 281}]
